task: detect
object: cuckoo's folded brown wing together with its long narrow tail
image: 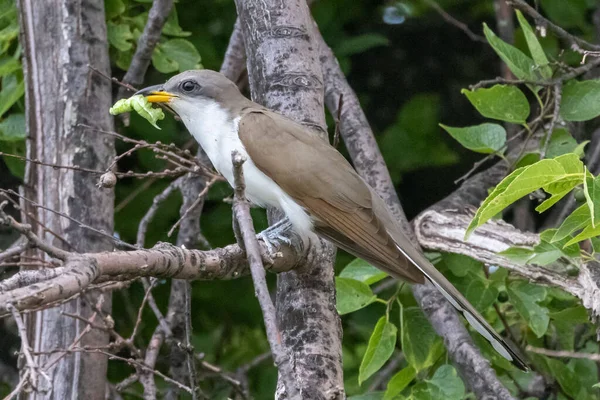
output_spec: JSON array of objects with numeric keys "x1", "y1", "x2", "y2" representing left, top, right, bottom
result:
[{"x1": 239, "y1": 111, "x2": 527, "y2": 370}]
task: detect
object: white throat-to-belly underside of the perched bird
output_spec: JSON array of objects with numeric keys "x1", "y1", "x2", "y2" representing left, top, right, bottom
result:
[{"x1": 170, "y1": 98, "x2": 312, "y2": 236}]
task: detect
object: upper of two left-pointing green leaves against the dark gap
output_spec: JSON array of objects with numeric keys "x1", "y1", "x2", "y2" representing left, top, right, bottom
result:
[{"x1": 461, "y1": 85, "x2": 530, "y2": 124}]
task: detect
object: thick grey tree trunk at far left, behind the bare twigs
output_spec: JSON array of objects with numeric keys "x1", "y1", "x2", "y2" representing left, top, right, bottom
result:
[{"x1": 17, "y1": 0, "x2": 114, "y2": 400}]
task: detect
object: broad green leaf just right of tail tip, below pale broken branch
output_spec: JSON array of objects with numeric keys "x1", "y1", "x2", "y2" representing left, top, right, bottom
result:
[{"x1": 507, "y1": 281, "x2": 550, "y2": 337}]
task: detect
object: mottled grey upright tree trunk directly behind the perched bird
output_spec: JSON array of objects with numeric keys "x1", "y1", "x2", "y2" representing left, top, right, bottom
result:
[{"x1": 236, "y1": 0, "x2": 344, "y2": 399}]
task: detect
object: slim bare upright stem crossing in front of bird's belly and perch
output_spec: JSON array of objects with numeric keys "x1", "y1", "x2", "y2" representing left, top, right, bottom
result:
[{"x1": 231, "y1": 151, "x2": 300, "y2": 400}]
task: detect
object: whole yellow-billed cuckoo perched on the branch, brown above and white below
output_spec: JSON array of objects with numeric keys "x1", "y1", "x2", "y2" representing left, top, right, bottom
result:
[{"x1": 137, "y1": 70, "x2": 527, "y2": 370}]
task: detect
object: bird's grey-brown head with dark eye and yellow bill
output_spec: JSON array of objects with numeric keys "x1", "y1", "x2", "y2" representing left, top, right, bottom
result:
[{"x1": 136, "y1": 69, "x2": 247, "y2": 121}]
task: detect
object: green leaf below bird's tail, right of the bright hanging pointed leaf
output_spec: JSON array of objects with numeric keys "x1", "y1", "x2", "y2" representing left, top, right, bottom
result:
[{"x1": 400, "y1": 307, "x2": 444, "y2": 372}]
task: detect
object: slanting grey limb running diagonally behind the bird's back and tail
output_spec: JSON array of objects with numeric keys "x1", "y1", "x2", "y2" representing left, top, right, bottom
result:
[{"x1": 317, "y1": 23, "x2": 511, "y2": 399}]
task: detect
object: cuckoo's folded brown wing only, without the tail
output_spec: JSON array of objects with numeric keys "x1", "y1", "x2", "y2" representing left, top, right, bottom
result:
[{"x1": 239, "y1": 111, "x2": 424, "y2": 283}]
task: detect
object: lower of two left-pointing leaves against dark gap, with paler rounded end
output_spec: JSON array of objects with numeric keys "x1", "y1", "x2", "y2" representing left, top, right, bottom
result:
[{"x1": 440, "y1": 123, "x2": 506, "y2": 154}]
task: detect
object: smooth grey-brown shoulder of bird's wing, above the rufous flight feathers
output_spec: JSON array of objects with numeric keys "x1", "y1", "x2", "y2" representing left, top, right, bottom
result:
[{"x1": 238, "y1": 110, "x2": 371, "y2": 211}]
